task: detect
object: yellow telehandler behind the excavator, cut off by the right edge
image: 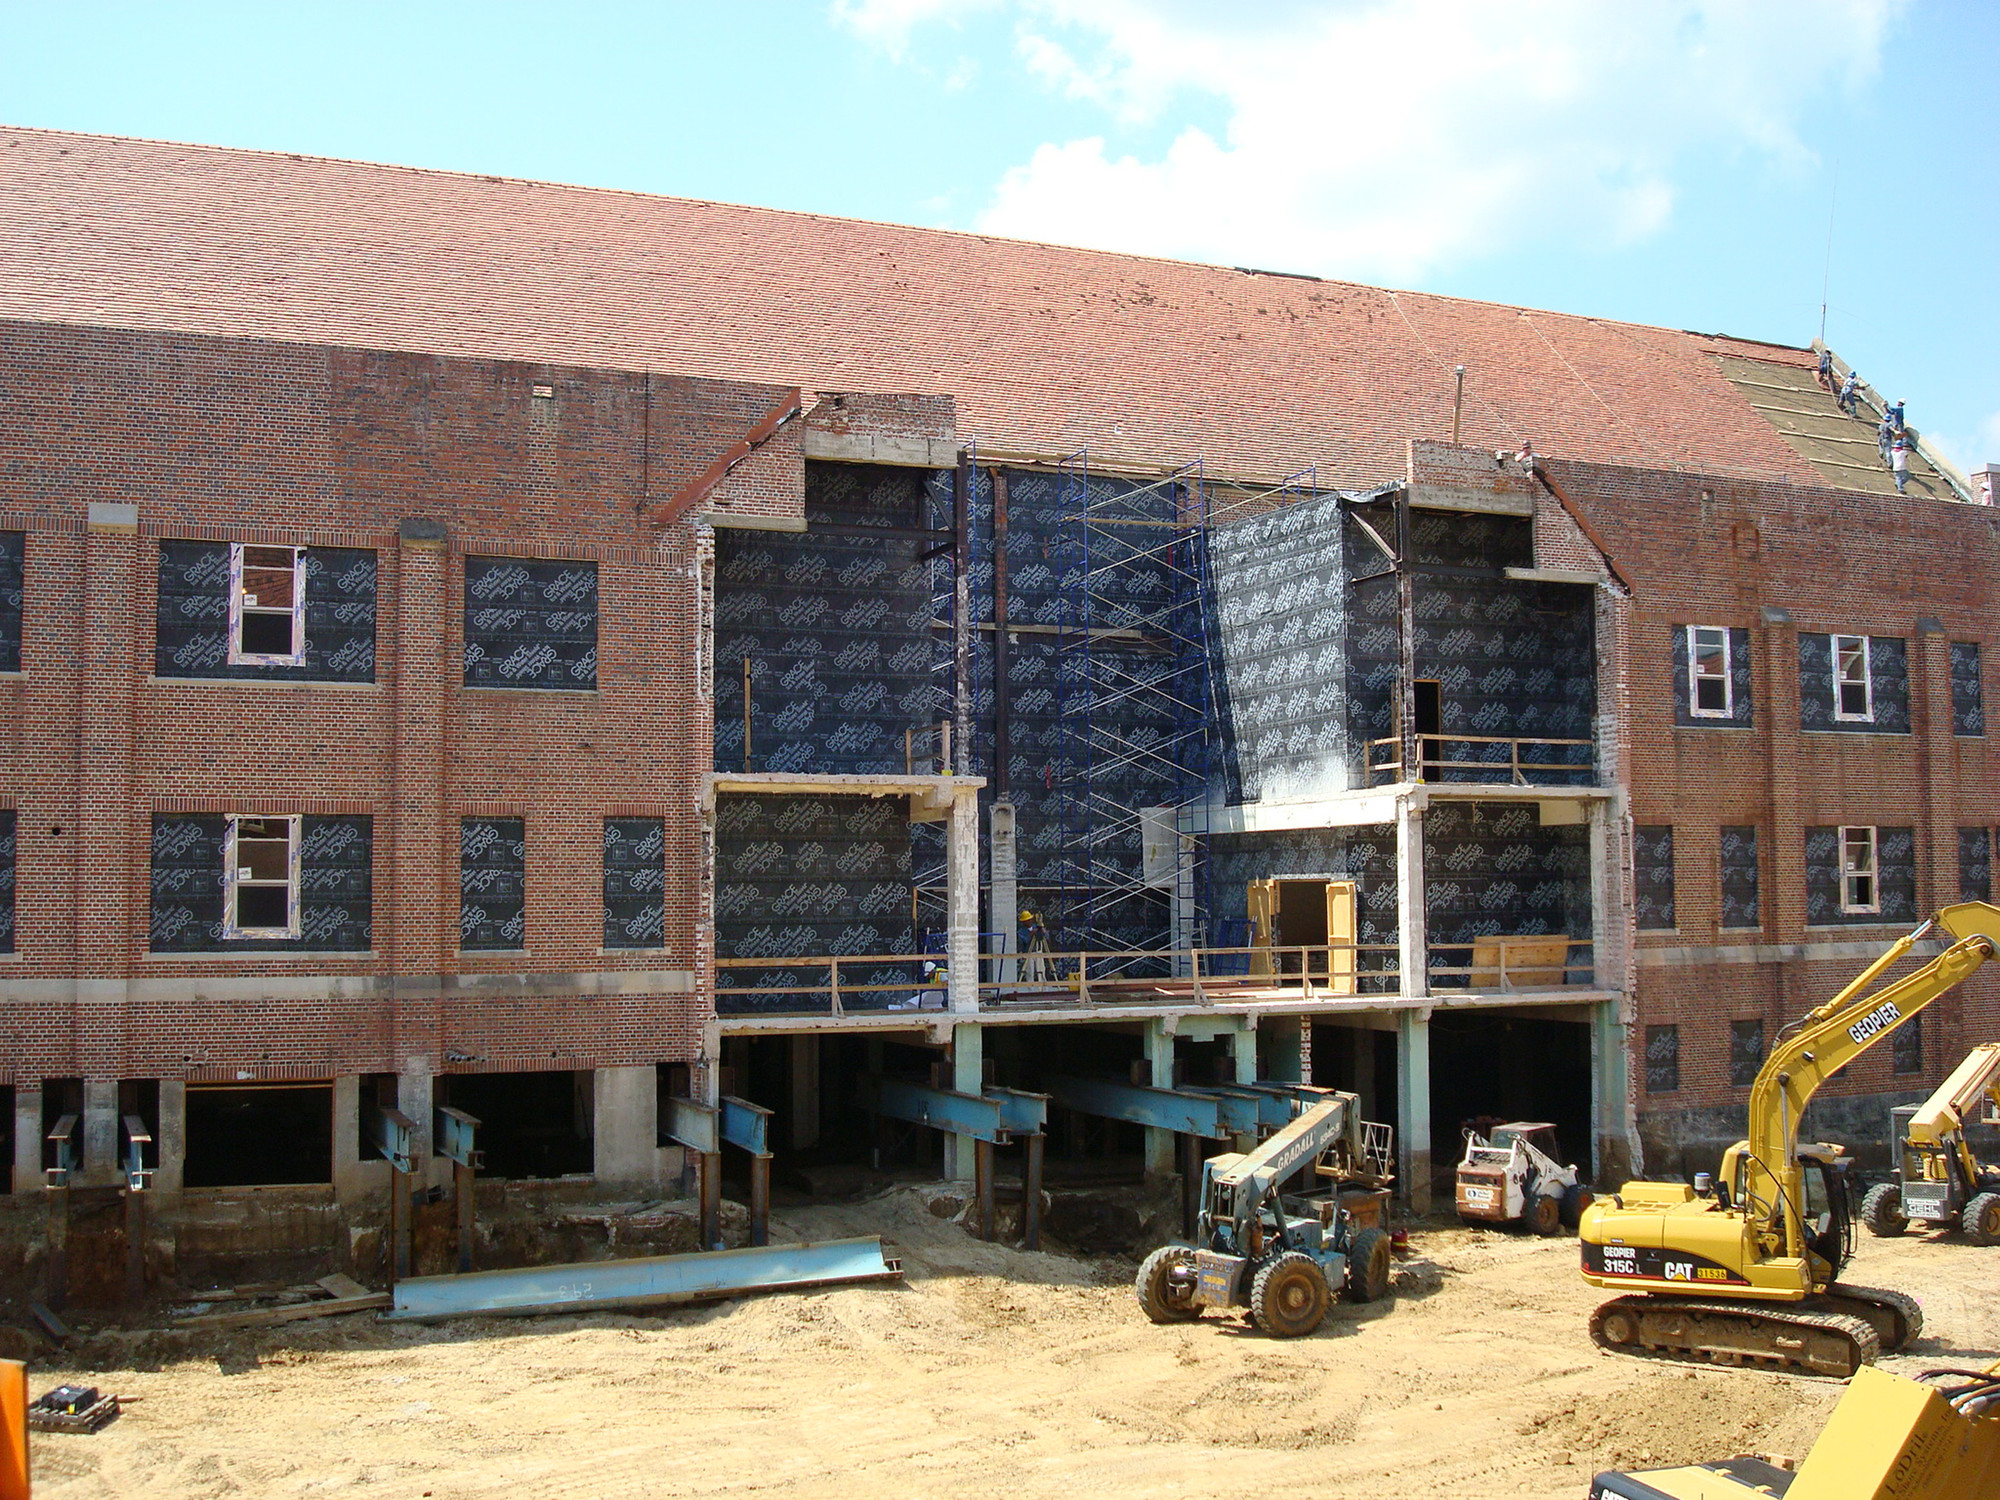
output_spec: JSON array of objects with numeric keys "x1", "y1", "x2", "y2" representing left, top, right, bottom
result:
[{"x1": 1862, "y1": 1042, "x2": 2000, "y2": 1244}]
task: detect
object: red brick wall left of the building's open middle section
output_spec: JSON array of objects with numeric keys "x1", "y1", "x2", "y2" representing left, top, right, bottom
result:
[{"x1": 0, "y1": 324, "x2": 820, "y2": 1080}]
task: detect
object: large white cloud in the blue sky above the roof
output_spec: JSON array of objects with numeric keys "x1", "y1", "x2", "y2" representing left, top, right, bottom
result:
[{"x1": 840, "y1": 0, "x2": 1902, "y2": 282}]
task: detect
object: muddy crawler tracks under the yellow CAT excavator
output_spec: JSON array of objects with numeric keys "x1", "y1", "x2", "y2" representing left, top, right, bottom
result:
[{"x1": 1590, "y1": 1286, "x2": 1880, "y2": 1380}]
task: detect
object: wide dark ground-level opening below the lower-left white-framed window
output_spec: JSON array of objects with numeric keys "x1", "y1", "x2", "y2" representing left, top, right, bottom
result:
[{"x1": 182, "y1": 1084, "x2": 334, "y2": 1188}]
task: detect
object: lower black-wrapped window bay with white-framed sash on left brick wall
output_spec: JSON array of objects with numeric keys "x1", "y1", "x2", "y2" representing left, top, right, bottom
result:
[{"x1": 148, "y1": 812, "x2": 374, "y2": 954}]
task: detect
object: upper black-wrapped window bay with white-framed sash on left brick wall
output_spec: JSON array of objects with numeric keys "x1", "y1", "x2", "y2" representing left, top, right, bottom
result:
[{"x1": 152, "y1": 538, "x2": 376, "y2": 682}]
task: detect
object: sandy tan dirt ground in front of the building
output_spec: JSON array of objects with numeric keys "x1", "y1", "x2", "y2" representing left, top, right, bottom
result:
[{"x1": 19, "y1": 1190, "x2": 2000, "y2": 1500}]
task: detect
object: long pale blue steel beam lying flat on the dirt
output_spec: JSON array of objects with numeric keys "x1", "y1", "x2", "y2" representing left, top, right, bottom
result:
[{"x1": 382, "y1": 1234, "x2": 902, "y2": 1320}]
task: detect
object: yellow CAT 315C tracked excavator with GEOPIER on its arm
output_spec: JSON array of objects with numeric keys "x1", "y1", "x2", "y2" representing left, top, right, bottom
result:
[{"x1": 1578, "y1": 902, "x2": 2000, "y2": 1378}]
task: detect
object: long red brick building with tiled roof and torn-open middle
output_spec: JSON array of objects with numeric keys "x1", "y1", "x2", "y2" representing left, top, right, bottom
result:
[{"x1": 0, "y1": 130, "x2": 2000, "y2": 1248}]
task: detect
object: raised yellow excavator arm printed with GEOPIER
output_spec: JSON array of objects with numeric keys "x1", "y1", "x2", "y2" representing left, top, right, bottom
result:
[{"x1": 1742, "y1": 902, "x2": 2000, "y2": 1256}]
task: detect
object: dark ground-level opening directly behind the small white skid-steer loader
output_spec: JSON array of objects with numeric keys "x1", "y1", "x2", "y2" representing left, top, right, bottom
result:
[{"x1": 1430, "y1": 1010, "x2": 1590, "y2": 1176}]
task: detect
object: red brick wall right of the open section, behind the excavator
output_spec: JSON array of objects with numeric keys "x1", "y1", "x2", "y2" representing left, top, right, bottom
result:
[{"x1": 1548, "y1": 452, "x2": 2000, "y2": 1168}]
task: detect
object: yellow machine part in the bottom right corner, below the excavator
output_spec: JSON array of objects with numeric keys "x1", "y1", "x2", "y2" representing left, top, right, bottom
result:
[{"x1": 1590, "y1": 1366, "x2": 2000, "y2": 1500}]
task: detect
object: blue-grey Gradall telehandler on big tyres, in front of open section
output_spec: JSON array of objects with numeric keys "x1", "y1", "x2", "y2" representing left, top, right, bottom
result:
[{"x1": 1134, "y1": 1094, "x2": 1390, "y2": 1338}]
